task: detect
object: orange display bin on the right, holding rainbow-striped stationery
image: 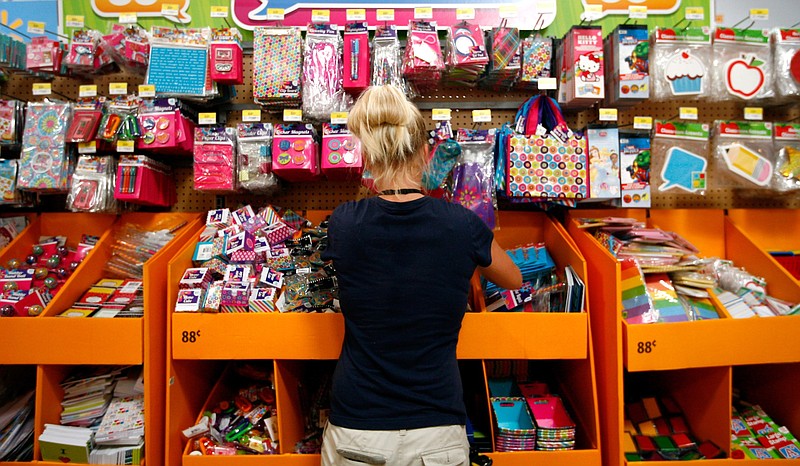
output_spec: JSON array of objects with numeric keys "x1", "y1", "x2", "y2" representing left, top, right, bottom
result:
[{"x1": 567, "y1": 209, "x2": 800, "y2": 465}]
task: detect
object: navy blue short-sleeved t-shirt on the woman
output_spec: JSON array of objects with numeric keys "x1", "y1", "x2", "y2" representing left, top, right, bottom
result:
[{"x1": 323, "y1": 197, "x2": 493, "y2": 430}]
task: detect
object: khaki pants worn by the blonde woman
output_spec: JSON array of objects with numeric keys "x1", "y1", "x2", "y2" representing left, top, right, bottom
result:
[{"x1": 322, "y1": 423, "x2": 469, "y2": 466}]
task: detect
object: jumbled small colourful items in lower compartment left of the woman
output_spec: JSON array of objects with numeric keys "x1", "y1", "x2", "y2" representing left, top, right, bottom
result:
[{"x1": 183, "y1": 361, "x2": 280, "y2": 456}]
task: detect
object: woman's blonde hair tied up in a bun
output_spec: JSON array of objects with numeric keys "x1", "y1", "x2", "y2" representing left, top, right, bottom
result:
[{"x1": 347, "y1": 85, "x2": 428, "y2": 189}]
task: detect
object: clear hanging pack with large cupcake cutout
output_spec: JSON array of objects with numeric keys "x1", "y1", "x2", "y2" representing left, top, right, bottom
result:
[{"x1": 650, "y1": 28, "x2": 712, "y2": 100}]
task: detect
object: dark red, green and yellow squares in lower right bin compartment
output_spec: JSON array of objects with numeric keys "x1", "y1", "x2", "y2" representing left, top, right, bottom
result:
[{"x1": 622, "y1": 396, "x2": 726, "y2": 461}]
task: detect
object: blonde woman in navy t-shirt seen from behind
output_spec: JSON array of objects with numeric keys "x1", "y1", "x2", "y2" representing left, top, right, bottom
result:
[{"x1": 322, "y1": 86, "x2": 522, "y2": 466}]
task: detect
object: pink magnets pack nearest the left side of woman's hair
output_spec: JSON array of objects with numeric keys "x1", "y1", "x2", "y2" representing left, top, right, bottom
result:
[{"x1": 322, "y1": 123, "x2": 364, "y2": 180}]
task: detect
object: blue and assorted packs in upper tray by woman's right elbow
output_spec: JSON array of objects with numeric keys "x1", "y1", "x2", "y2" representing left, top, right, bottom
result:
[{"x1": 483, "y1": 243, "x2": 586, "y2": 312}]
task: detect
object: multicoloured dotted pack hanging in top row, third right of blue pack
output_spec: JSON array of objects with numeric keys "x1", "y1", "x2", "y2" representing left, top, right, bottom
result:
[{"x1": 253, "y1": 27, "x2": 303, "y2": 107}]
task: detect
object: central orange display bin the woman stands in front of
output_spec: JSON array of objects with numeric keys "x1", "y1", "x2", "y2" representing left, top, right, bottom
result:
[{"x1": 166, "y1": 211, "x2": 600, "y2": 466}]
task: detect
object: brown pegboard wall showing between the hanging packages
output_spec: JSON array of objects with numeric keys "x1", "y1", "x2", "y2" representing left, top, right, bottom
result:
[{"x1": 0, "y1": 53, "x2": 800, "y2": 211}]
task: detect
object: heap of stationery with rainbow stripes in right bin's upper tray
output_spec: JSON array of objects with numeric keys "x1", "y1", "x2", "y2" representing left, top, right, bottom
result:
[{"x1": 579, "y1": 217, "x2": 800, "y2": 324}]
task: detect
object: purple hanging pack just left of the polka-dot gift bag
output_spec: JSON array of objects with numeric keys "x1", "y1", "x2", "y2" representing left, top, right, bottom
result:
[{"x1": 452, "y1": 129, "x2": 496, "y2": 229}]
